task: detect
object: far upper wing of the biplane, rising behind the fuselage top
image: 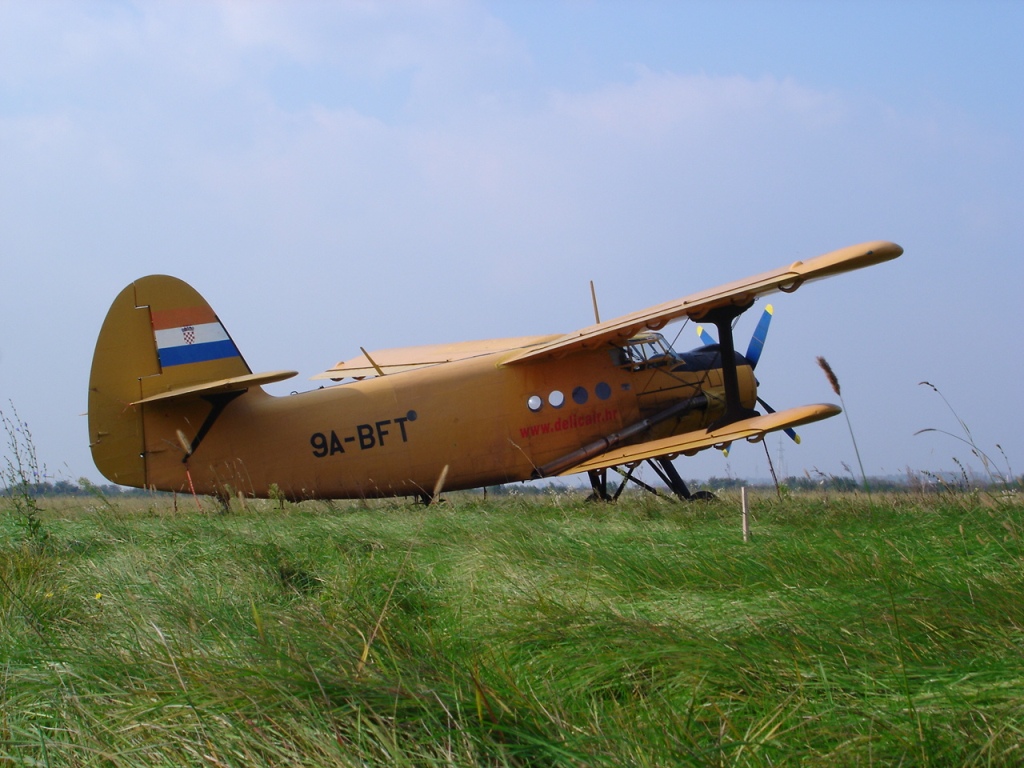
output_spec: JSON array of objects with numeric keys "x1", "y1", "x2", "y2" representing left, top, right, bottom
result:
[{"x1": 312, "y1": 336, "x2": 559, "y2": 381}]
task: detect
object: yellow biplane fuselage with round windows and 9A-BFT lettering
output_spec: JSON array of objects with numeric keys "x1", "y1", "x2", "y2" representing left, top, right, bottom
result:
[{"x1": 143, "y1": 349, "x2": 756, "y2": 499}]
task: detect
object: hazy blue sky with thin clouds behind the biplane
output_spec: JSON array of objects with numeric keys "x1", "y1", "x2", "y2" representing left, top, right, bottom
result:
[{"x1": 0, "y1": 0, "x2": 1024, "y2": 487}]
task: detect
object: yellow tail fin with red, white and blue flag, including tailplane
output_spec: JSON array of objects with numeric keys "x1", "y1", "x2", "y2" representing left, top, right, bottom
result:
[{"x1": 89, "y1": 274, "x2": 291, "y2": 486}]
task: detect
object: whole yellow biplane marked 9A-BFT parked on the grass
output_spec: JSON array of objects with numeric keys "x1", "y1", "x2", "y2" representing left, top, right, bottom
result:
[{"x1": 89, "y1": 242, "x2": 902, "y2": 503}]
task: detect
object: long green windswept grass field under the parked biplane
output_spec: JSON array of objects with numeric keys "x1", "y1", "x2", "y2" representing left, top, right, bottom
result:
[{"x1": 0, "y1": 492, "x2": 1024, "y2": 766}]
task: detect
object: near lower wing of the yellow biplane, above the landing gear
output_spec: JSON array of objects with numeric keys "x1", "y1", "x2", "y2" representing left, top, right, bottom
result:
[{"x1": 560, "y1": 403, "x2": 842, "y2": 474}]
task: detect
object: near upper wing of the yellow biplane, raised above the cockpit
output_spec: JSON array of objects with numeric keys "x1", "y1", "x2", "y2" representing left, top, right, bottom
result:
[{"x1": 507, "y1": 241, "x2": 903, "y2": 362}]
